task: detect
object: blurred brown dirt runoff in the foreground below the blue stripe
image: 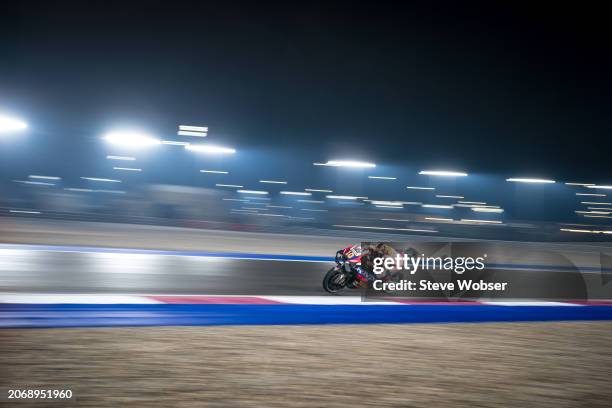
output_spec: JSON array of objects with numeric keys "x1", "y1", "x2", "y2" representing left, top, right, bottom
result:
[{"x1": 0, "y1": 322, "x2": 612, "y2": 408}]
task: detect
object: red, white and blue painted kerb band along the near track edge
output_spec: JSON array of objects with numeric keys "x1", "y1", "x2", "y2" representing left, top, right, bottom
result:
[{"x1": 0, "y1": 293, "x2": 612, "y2": 328}]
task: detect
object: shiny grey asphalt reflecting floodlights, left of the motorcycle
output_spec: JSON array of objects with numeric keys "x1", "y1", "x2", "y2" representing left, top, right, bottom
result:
[{"x1": 0, "y1": 245, "x2": 331, "y2": 295}]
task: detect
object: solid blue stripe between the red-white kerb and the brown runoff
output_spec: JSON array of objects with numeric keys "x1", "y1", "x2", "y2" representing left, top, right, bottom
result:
[{"x1": 0, "y1": 304, "x2": 612, "y2": 328}]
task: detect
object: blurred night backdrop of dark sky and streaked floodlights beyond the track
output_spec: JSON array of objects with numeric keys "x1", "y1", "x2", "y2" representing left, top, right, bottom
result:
[{"x1": 0, "y1": 1, "x2": 612, "y2": 241}]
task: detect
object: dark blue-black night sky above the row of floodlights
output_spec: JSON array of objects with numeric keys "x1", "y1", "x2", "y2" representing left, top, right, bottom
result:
[{"x1": 0, "y1": 1, "x2": 612, "y2": 182}]
